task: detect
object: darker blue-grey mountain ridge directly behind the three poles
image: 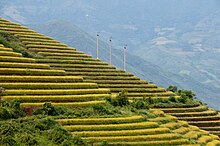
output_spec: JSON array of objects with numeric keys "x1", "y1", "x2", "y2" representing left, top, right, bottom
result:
[{"x1": 30, "y1": 20, "x2": 220, "y2": 109}]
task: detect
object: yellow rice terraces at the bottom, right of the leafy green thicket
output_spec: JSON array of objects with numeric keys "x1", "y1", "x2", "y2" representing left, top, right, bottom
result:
[{"x1": 57, "y1": 112, "x2": 219, "y2": 146}]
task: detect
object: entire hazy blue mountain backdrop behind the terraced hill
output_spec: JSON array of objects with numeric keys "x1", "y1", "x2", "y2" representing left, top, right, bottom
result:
[{"x1": 0, "y1": 0, "x2": 220, "y2": 108}]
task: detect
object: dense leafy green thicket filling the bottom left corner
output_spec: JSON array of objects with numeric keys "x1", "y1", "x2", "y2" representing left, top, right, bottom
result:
[{"x1": 0, "y1": 116, "x2": 86, "y2": 146}]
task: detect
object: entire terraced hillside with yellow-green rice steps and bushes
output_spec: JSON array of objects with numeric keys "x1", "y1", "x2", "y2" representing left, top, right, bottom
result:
[{"x1": 0, "y1": 0, "x2": 220, "y2": 146}]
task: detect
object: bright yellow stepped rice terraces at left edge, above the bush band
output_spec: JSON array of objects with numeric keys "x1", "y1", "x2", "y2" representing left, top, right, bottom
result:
[{"x1": 0, "y1": 44, "x2": 110, "y2": 106}]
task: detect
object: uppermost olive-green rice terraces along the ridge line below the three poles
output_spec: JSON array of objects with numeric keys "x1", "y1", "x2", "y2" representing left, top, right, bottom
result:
[{"x1": 0, "y1": 19, "x2": 173, "y2": 98}]
